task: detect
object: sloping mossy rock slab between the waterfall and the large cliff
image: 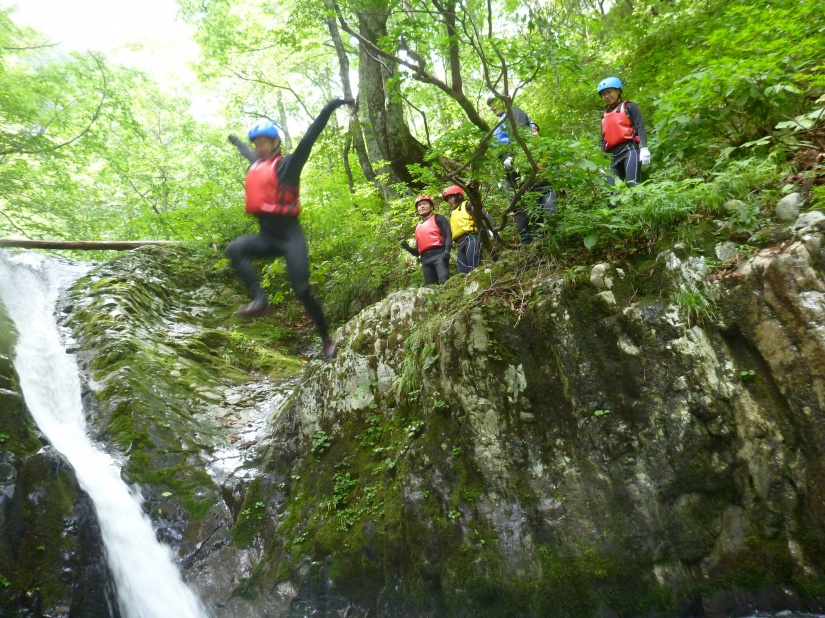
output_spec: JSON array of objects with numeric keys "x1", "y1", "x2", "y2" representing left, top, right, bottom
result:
[{"x1": 63, "y1": 247, "x2": 303, "y2": 618}]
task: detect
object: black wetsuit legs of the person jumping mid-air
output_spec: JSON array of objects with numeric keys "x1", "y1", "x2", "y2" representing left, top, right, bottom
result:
[{"x1": 226, "y1": 214, "x2": 329, "y2": 342}]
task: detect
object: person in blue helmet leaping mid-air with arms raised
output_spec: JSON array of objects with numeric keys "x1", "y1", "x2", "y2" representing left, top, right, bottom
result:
[{"x1": 226, "y1": 99, "x2": 354, "y2": 358}]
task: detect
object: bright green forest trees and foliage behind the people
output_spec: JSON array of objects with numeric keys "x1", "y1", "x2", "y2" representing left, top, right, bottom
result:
[{"x1": 0, "y1": 0, "x2": 825, "y2": 318}]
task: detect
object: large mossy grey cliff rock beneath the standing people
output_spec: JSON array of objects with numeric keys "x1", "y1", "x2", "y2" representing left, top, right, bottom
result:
[{"x1": 259, "y1": 218, "x2": 825, "y2": 616}]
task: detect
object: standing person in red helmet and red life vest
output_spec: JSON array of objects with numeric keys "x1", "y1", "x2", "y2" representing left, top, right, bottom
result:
[{"x1": 401, "y1": 195, "x2": 453, "y2": 285}]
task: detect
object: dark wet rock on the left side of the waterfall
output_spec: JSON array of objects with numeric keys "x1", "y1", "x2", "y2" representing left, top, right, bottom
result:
[{"x1": 0, "y1": 307, "x2": 119, "y2": 618}]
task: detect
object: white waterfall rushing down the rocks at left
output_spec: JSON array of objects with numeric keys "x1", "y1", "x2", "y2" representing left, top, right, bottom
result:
[{"x1": 0, "y1": 252, "x2": 206, "y2": 618}]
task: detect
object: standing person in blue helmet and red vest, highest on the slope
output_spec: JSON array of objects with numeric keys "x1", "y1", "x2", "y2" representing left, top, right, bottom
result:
[{"x1": 598, "y1": 77, "x2": 650, "y2": 187}]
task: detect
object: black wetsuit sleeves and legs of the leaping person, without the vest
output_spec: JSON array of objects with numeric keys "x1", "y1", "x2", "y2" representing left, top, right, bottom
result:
[{"x1": 226, "y1": 99, "x2": 346, "y2": 343}]
